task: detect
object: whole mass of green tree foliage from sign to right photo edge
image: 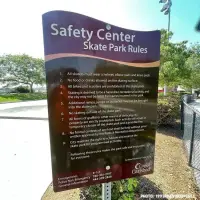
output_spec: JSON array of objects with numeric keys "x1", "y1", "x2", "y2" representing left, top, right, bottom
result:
[{"x1": 159, "y1": 30, "x2": 200, "y2": 89}]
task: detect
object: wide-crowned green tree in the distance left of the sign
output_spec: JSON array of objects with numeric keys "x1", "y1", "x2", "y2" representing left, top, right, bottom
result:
[{"x1": 0, "y1": 54, "x2": 45, "y2": 93}]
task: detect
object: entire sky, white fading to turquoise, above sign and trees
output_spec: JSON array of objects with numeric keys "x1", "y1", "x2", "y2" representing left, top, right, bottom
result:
[{"x1": 0, "y1": 0, "x2": 200, "y2": 58}]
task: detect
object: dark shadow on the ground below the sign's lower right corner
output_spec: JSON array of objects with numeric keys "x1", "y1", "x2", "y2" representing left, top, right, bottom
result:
[{"x1": 135, "y1": 177, "x2": 168, "y2": 200}]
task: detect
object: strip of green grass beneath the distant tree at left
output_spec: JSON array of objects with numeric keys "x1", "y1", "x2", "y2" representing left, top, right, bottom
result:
[{"x1": 0, "y1": 93, "x2": 47, "y2": 103}]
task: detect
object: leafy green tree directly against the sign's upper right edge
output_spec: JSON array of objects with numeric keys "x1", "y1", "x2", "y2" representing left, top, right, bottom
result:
[{"x1": 159, "y1": 30, "x2": 190, "y2": 92}]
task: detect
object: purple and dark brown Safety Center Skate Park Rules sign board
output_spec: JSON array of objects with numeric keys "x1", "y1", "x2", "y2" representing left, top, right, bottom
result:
[{"x1": 43, "y1": 11, "x2": 160, "y2": 192}]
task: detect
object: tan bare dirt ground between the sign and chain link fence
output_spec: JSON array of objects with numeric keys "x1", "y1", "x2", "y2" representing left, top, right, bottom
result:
[{"x1": 139, "y1": 129, "x2": 200, "y2": 200}]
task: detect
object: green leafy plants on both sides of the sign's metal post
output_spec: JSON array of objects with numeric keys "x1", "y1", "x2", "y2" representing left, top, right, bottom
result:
[{"x1": 82, "y1": 178, "x2": 138, "y2": 200}]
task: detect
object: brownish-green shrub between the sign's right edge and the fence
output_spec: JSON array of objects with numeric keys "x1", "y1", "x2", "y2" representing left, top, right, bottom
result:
[{"x1": 157, "y1": 94, "x2": 181, "y2": 126}]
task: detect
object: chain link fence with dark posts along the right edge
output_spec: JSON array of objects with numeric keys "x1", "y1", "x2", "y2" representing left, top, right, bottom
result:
[{"x1": 181, "y1": 95, "x2": 200, "y2": 188}]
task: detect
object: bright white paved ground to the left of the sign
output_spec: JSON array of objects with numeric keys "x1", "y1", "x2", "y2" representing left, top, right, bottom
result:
[{"x1": 0, "y1": 101, "x2": 52, "y2": 200}]
